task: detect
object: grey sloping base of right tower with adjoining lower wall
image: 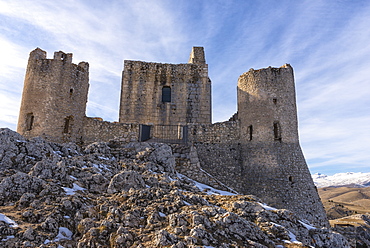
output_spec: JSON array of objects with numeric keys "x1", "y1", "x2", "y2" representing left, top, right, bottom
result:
[{"x1": 195, "y1": 143, "x2": 328, "y2": 226}]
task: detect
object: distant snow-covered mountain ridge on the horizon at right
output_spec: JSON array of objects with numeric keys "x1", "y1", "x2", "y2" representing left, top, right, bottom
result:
[{"x1": 312, "y1": 172, "x2": 370, "y2": 188}]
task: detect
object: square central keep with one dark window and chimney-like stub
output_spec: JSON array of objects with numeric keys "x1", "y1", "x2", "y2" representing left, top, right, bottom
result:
[{"x1": 119, "y1": 47, "x2": 211, "y2": 125}]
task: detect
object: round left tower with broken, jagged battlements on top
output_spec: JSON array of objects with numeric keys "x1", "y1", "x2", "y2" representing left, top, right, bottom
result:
[{"x1": 17, "y1": 48, "x2": 89, "y2": 142}]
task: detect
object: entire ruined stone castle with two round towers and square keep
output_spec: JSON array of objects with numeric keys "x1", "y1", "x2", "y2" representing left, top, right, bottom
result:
[{"x1": 17, "y1": 47, "x2": 327, "y2": 226}]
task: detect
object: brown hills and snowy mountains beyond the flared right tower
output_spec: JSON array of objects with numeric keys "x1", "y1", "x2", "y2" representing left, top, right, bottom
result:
[{"x1": 312, "y1": 172, "x2": 370, "y2": 247}]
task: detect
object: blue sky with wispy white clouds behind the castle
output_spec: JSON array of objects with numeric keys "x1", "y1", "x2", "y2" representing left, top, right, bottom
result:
[{"x1": 0, "y1": 0, "x2": 370, "y2": 175}]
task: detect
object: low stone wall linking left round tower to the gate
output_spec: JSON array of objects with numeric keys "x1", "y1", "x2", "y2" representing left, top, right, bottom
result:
[{"x1": 82, "y1": 117, "x2": 139, "y2": 144}]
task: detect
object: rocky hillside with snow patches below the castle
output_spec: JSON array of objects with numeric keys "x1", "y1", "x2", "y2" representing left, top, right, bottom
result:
[{"x1": 0, "y1": 129, "x2": 354, "y2": 248}]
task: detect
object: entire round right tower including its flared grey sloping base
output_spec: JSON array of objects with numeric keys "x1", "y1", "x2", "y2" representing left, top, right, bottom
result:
[{"x1": 238, "y1": 64, "x2": 327, "y2": 225}]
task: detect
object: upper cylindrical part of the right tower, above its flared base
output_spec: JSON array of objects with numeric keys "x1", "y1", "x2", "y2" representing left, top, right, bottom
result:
[{"x1": 238, "y1": 64, "x2": 298, "y2": 143}]
